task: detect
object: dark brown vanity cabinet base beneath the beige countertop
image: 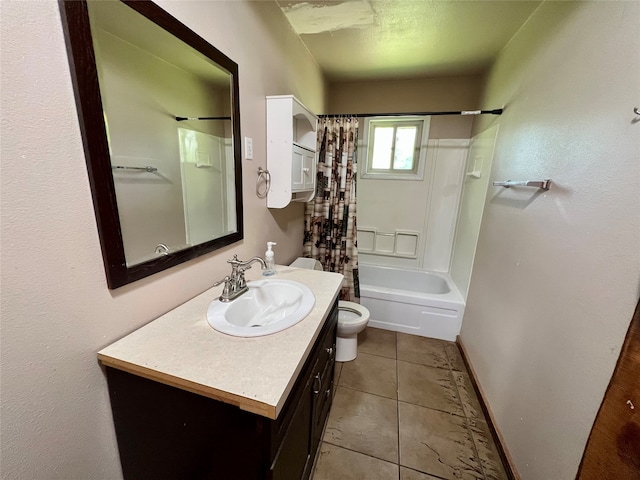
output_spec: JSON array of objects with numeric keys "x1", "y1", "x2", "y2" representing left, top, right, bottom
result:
[{"x1": 106, "y1": 301, "x2": 338, "y2": 480}]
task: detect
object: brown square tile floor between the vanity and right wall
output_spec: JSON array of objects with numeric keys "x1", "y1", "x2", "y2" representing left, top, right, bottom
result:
[{"x1": 313, "y1": 328, "x2": 507, "y2": 480}]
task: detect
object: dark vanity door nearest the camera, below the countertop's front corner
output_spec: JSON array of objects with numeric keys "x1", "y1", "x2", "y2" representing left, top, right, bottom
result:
[{"x1": 271, "y1": 364, "x2": 313, "y2": 480}]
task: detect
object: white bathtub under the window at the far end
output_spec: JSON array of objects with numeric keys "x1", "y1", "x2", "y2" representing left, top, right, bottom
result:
[{"x1": 358, "y1": 264, "x2": 464, "y2": 341}]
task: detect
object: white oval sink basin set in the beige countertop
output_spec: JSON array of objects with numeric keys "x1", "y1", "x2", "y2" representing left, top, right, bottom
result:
[{"x1": 207, "y1": 278, "x2": 316, "y2": 337}]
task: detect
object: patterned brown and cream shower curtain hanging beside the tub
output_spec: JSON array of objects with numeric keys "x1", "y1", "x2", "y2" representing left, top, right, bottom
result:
[{"x1": 303, "y1": 117, "x2": 360, "y2": 302}]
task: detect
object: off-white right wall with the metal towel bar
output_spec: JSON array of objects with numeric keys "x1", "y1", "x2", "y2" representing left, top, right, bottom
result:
[{"x1": 462, "y1": 1, "x2": 640, "y2": 480}]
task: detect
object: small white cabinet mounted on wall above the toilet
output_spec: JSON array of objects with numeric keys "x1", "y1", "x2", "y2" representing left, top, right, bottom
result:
[{"x1": 267, "y1": 95, "x2": 318, "y2": 208}]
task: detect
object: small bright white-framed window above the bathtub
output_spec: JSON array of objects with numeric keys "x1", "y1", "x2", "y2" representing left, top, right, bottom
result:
[{"x1": 363, "y1": 117, "x2": 429, "y2": 180}]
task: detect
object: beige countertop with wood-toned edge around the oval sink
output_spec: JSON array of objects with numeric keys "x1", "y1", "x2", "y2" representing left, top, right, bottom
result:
[{"x1": 98, "y1": 266, "x2": 342, "y2": 419}]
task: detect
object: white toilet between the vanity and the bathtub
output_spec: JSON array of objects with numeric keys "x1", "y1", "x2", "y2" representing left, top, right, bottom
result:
[{"x1": 291, "y1": 257, "x2": 370, "y2": 362}]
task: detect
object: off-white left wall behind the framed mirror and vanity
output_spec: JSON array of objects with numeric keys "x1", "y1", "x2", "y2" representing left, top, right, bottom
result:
[{"x1": 0, "y1": 0, "x2": 325, "y2": 480}]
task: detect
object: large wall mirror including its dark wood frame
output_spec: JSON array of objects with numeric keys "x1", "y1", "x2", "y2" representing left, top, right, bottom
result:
[{"x1": 59, "y1": 0, "x2": 243, "y2": 289}]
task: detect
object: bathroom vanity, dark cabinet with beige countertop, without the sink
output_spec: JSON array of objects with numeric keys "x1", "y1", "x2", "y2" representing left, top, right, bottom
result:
[{"x1": 98, "y1": 266, "x2": 342, "y2": 480}]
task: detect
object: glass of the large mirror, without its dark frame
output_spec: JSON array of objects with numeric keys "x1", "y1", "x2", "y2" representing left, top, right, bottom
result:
[{"x1": 87, "y1": 1, "x2": 238, "y2": 267}]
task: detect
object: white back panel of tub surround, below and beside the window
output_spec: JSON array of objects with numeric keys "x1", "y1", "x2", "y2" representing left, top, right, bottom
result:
[{"x1": 358, "y1": 139, "x2": 469, "y2": 272}]
